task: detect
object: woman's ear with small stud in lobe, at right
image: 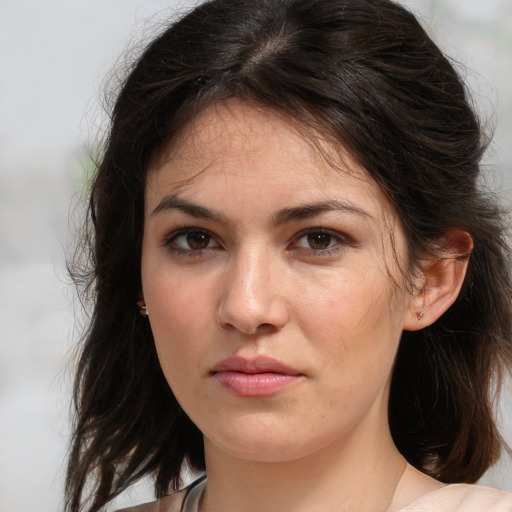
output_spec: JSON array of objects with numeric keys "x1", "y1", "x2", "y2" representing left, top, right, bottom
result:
[{"x1": 403, "y1": 230, "x2": 473, "y2": 331}]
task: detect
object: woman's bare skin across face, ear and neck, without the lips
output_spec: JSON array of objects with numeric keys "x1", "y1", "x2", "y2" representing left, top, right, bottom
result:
[{"x1": 142, "y1": 100, "x2": 464, "y2": 512}]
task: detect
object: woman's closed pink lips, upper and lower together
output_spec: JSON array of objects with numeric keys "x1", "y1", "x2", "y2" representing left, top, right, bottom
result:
[{"x1": 212, "y1": 356, "x2": 302, "y2": 398}]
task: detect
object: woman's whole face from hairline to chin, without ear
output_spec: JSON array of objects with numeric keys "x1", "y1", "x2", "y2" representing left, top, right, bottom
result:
[{"x1": 142, "y1": 100, "x2": 411, "y2": 461}]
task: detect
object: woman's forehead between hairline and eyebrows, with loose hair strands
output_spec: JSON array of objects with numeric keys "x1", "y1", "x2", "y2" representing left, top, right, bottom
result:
[{"x1": 146, "y1": 99, "x2": 391, "y2": 218}]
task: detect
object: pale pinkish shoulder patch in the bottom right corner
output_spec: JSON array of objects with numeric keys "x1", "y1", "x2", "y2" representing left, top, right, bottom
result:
[{"x1": 402, "y1": 484, "x2": 512, "y2": 512}]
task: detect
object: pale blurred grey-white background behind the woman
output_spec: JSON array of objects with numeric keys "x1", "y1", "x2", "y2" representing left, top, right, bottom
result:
[{"x1": 0, "y1": 0, "x2": 512, "y2": 512}]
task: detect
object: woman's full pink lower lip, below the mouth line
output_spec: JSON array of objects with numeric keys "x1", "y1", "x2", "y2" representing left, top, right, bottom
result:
[{"x1": 214, "y1": 371, "x2": 301, "y2": 398}]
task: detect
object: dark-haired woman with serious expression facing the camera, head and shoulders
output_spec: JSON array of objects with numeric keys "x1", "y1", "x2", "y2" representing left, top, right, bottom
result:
[{"x1": 67, "y1": 0, "x2": 512, "y2": 512}]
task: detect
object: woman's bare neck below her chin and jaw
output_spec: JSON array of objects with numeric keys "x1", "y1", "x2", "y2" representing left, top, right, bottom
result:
[{"x1": 201, "y1": 412, "x2": 405, "y2": 512}]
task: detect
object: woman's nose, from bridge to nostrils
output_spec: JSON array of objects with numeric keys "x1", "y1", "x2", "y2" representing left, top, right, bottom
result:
[{"x1": 218, "y1": 249, "x2": 289, "y2": 335}]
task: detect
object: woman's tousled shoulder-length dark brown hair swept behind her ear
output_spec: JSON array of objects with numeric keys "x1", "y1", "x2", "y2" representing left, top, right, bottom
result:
[{"x1": 66, "y1": 0, "x2": 512, "y2": 512}]
